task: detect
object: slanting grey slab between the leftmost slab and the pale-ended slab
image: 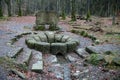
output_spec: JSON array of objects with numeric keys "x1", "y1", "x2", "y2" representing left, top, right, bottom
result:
[{"x1": 16, "y1": 49, "x2": 32, "y2": 65}]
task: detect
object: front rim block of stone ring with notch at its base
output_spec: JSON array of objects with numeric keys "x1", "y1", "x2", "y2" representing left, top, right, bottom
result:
[{"x1": 51, "y1": 43, "x2": 67, "y2": 54}]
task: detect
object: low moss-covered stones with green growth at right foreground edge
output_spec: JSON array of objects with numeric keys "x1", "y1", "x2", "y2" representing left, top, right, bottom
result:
[{"x1": 87, "y1": 51, "x2": 120, "y2": 69}]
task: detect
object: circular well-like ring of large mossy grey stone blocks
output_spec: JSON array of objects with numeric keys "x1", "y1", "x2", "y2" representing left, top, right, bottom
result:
[{"x1": 26, "y1": 31, "x2": 79, "y2": 54}]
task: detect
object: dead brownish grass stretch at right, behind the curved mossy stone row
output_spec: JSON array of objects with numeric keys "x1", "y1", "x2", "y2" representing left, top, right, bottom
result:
[{"x1": 68, "y1": 18, "x2": 120, "y2": 44}]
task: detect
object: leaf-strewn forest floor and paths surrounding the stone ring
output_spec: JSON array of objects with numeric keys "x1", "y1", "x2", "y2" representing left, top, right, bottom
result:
[{"x1": 0, "y1": 16, "x2": 120, "y2": 80}]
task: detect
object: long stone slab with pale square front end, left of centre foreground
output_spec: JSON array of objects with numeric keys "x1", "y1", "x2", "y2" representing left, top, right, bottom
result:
[{"x1": 29, "y1": 50, "x2": 43, "y2": 72}]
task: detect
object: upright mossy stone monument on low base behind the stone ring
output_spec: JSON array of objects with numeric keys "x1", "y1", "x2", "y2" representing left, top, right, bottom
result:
[{"x1": 35, "y1": 11, "x2": 58, "y2": 30}]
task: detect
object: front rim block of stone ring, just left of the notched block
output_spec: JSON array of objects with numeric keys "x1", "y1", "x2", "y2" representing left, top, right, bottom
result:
[{"x1": 35, "y1": 42, "x2": 50, "y2": 53}]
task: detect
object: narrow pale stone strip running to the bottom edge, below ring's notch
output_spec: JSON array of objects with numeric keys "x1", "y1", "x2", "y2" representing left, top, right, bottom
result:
[{"x1": 63, "y1": 64, "x2": 71, "y2": 80}]
